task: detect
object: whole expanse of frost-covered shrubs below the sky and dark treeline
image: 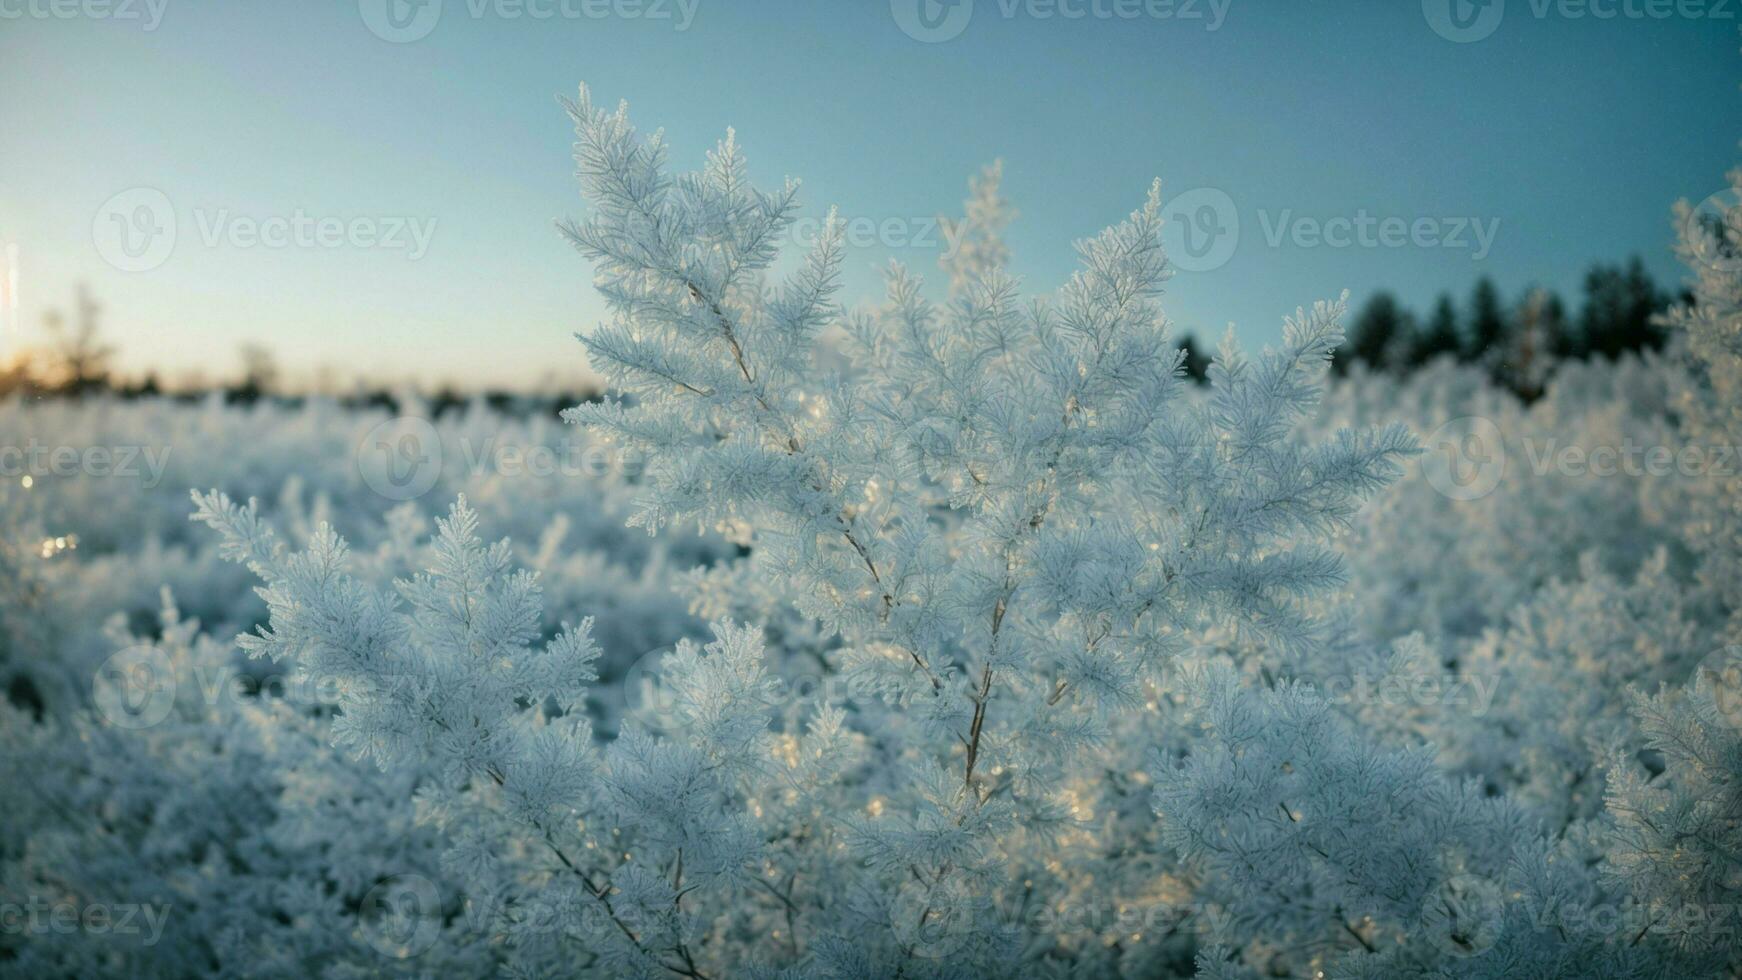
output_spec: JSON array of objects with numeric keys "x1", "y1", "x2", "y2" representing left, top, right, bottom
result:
[{"x1": 0, "y1": 96, "x2": 1742, "y2": 978}]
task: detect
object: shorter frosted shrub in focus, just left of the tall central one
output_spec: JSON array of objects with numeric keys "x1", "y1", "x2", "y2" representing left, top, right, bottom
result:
[{"x1": 197, "y1": 494, "x2": 855, "y2": 977}]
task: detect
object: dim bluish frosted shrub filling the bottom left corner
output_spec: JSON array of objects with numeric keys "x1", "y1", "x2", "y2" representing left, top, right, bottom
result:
[{"x1": 0, "y1": 590, "x2": 495, "y2": 977}]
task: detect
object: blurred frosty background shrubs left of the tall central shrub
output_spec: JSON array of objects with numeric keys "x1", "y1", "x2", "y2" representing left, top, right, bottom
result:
[{"x1": 0, "y1": 397, "x2": 733, "y2": 724}]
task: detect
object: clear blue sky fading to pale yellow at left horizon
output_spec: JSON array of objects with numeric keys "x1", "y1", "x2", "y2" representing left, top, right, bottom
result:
[{"x1": 0, "y1": 0, "x2": 1742, "y2": 388}]
